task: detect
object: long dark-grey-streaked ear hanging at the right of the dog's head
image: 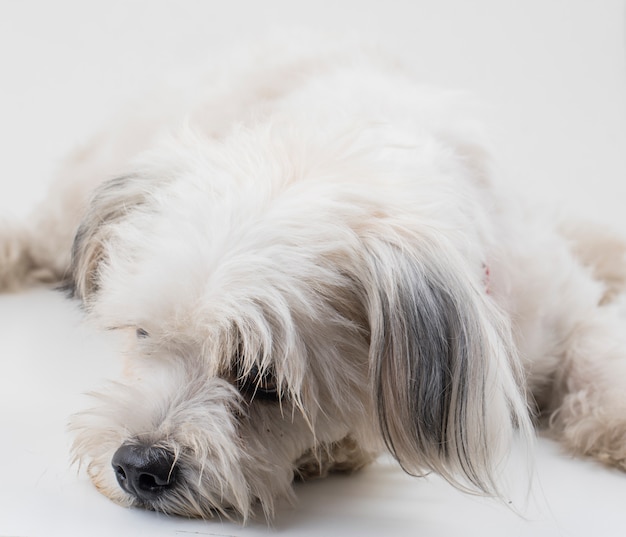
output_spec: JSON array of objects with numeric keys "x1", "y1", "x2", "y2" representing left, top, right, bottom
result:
[{"x1": 365, "y1": 237, "x2": 532, "y2": 495}]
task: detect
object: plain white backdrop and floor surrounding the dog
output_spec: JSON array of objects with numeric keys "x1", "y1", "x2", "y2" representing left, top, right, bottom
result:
[{"x1": 0, "y1": 0, "x2": 626, "y2": 537}]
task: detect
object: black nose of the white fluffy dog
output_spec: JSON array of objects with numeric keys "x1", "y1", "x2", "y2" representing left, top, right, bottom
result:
[{"x1": 111, "y1": 444, "x2": 177, "y2": 501}]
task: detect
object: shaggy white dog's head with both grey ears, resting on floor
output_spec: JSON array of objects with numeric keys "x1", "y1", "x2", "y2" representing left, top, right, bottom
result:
[{"x1": 68, "y1": 124, "x2": 527, "y2": 518}]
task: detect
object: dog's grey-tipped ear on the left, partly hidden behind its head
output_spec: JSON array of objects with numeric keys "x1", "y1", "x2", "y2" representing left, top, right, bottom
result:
[{"x1": 70, "y1": 175, "x2": 148, "y2": 305}]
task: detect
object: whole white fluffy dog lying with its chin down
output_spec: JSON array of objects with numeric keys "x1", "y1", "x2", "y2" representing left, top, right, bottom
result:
[{"x1": 0, "y1": 43, "x2": 626, "y2": 519}]
